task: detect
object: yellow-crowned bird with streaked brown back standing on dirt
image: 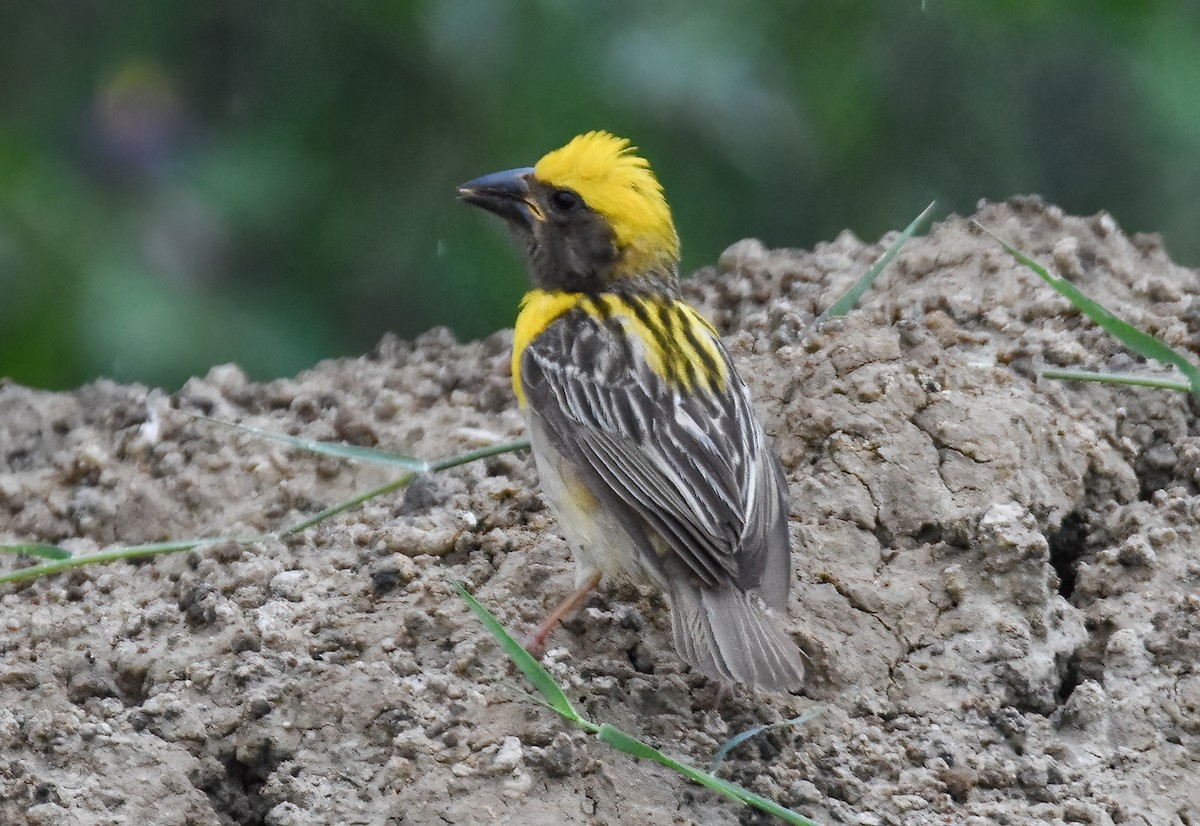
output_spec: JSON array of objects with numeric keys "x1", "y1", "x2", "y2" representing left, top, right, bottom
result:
[{"x1": 458, "y1": 131, "x2": 804, "y2": 692}]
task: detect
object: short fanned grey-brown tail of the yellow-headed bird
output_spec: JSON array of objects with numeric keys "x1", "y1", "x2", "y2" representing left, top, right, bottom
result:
[{"x1": 671, "y1": 586, "x2": 804, "y2": 692}]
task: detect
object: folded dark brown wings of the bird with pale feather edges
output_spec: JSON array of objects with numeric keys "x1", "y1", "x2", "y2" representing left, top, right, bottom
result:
[{"x1": 521, "y1": 311, "x2": 787, "y2": 590}]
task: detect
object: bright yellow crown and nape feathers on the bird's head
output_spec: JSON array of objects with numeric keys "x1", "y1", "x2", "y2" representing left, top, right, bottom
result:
[{"x1": 534, "y1": 132, "x2": 679, "y2": 267}]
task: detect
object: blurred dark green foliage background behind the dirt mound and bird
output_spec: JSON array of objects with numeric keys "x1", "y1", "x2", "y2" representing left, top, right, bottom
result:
[{"x1": 0, "y1": 0, "x2": 1200, "y2": 389}]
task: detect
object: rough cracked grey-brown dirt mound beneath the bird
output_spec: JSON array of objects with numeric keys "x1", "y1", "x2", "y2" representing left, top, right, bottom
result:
[{"x1": 0, "y1": 198, "x2": 1200, "y2": 826}]
